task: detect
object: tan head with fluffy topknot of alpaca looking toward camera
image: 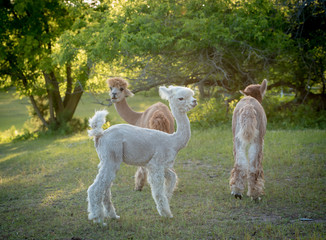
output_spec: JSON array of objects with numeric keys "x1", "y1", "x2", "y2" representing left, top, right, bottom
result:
[{"x1": 107, "y1": 77, "x2": 134, "y2": 103}]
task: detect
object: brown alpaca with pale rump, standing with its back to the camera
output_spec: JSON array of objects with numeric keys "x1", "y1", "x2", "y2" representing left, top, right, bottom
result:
[{"x1": 230, "y1": 79, "x2": 267, "y2": 200}]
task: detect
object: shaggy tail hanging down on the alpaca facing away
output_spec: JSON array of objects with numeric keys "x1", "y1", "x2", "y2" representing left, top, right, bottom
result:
[{"x1": 237, "y1": 104, "x2": 258, "y2": 143}]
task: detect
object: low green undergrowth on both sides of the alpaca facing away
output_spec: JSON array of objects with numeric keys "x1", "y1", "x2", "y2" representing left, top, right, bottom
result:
[{"x1": 189, "y1": 94, "x2": 326, "y2": 129}]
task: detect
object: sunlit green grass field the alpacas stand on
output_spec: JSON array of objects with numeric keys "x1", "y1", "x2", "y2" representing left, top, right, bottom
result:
[{"x1": 0, "y1": 90, "x2": 326, "y2": 239}]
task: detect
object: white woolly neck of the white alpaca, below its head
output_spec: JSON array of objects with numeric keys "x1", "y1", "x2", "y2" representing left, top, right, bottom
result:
[{"x1": 171, "y1": 108, "x2": 191, "y2": 151}]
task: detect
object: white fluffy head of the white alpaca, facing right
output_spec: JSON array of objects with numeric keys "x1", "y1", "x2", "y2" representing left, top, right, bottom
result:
[{"x1": 159, "y1": 86, "x2": 197, "y2": 113}]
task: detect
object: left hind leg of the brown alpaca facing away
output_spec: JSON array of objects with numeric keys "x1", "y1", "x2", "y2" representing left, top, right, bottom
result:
[{"x1": 229, "y1": 138, "x2": 248, "y2": 199}]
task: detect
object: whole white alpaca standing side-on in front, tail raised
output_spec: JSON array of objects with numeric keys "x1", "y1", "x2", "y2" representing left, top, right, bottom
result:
[{"x1": 87, "y1": 86, "x2": 197, "y2": 223}]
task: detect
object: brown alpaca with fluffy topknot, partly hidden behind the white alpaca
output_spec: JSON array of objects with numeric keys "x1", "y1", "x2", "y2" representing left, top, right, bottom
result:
[{"x1": 107, "y1": 77, "x2": 174, "y2": 191}]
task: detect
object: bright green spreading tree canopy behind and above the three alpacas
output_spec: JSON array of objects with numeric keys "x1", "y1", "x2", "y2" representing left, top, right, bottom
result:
[{"x1": 84, "y1": 0, "x2": 289, "y2": 92}]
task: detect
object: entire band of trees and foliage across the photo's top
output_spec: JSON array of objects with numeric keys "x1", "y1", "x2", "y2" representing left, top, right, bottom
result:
[{"x1": 0, "y1": 0, "x2": 326, "y2": 133}]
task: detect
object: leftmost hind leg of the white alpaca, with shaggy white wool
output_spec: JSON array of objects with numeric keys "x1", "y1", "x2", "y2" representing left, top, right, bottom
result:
[{"x1": 87, "y1": 160, "x2": 118, "y2": 223}]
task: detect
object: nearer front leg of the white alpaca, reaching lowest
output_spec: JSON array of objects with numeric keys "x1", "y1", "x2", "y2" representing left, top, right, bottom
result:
[{"x1": 147, "y1": 168, "x2": 173, "y2": 218}]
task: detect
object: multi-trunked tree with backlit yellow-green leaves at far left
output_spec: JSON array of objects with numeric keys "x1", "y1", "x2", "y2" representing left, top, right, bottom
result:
[{"x1": 0, "y1": 0, "x2": 93, "y2": 127}]
